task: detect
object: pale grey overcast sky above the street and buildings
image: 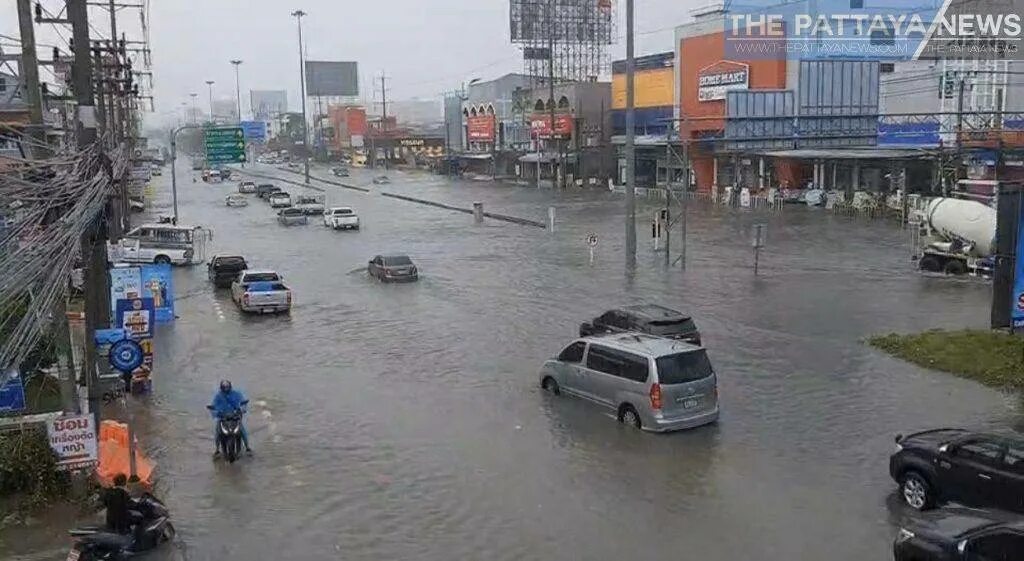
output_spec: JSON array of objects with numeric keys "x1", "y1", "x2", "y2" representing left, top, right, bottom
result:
[{"x1": 0, "y1": 0, "x2": 710, "y2": 124}]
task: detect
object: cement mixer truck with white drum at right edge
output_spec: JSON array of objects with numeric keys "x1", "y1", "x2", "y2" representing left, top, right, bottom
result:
[{"x1": 912, "y1": 197, "x2": 995, "y2": 276}]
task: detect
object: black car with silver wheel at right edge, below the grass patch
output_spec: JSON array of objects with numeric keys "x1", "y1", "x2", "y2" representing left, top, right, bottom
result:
[{"x1": 889, "y1": 429, "x2": 1024, "y2": 512}]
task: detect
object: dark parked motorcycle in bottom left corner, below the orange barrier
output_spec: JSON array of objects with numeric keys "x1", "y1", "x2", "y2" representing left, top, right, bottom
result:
[{"x1": 66, "y1": 493, "x2": 175, "y2": 561}]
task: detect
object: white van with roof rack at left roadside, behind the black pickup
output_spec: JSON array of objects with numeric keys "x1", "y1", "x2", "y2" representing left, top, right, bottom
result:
[{"x1": 108, "y1": 224, "x2": 209, "y2": 265}]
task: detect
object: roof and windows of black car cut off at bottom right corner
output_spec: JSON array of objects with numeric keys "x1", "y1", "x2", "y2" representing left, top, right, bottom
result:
[{"x1": 893, "y1": 508, "x2": 1024, "y2": 561}]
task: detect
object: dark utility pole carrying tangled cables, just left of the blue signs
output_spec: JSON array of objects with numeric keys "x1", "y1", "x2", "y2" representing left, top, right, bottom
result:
[{"x1": 68, "y1": 0, "x2": 103, "y2": 427}]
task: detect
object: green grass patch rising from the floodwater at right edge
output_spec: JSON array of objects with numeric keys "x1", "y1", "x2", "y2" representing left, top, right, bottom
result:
[{"x1": 867, "y1": 330, "x2": 1024, "y2": 391}]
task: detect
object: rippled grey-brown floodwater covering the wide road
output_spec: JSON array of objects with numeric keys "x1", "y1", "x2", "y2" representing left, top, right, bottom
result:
[{"x1": 6, "y1": 158, "x2": 1018, "y2": 561}]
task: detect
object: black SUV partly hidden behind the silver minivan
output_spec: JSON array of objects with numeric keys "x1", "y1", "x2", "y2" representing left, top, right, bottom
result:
[{"x1": 580, "y1": 304, "x2": 700, "y2": 345}]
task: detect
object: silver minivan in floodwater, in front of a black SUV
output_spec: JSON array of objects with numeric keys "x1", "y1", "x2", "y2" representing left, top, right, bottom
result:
[{"x1": 540, "y1": 333, "x2": 718, "y2": 432}]
